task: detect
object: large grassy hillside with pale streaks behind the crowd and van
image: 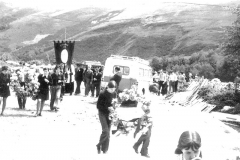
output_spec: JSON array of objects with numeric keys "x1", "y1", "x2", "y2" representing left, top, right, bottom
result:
[{"x1": 0, "y1": 3, "x2": 236, "y2": 62}]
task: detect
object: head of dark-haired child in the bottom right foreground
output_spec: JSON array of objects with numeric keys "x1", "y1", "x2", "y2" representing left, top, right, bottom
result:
[{"x1": 175, "y1": 131, "x2": 201, "y2": 160}]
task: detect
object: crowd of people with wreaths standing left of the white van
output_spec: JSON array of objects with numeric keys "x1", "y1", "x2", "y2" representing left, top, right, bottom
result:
[{"x1": 0, "y1": 63, "x2": 103, "y2": 116}]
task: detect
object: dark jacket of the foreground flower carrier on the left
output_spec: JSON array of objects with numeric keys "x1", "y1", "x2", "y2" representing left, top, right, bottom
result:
[{"x1": 97, "y1": 89, "x2": 116, "y2": 115}]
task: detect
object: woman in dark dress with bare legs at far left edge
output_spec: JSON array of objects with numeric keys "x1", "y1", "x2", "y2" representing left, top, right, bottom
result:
[{"x1": 0, "y1": 66, "x2": 10, "y2": 115}]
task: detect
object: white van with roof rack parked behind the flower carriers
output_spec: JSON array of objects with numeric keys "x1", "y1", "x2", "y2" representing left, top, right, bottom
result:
[{"x1": 101, "y1": 55, "x2": 152, "y2": 93}]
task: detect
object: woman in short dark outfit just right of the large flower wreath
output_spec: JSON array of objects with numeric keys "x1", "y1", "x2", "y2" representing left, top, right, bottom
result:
[{"x1": 35, "y1": 68, "x2": 51, "y2": 116}]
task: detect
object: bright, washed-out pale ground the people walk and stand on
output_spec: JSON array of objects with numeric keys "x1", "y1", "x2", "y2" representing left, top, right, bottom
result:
[{"x1": 0, "y1": 86, "x2": 240, "y2": 160}]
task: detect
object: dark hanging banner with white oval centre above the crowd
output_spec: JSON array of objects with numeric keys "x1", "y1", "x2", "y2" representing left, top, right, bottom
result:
[{"x1": 54, "y1": 41, "x2": 75, "y2": 66}]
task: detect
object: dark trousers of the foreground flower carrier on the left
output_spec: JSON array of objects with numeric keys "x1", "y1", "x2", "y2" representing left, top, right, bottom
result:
[{"x1": 97, "y1": 111, "x2": 111, "y2": 152}]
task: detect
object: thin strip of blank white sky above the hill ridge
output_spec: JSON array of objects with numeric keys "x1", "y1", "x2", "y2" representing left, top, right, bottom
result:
[{"x1": 0, "y1": 0, "x2": 236, "y2": 10}]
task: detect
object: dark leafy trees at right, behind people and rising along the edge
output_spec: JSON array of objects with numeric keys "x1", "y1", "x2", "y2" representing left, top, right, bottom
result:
[{"x1": 151, "y1": 6, "x2": 240, "y2": 82}]
